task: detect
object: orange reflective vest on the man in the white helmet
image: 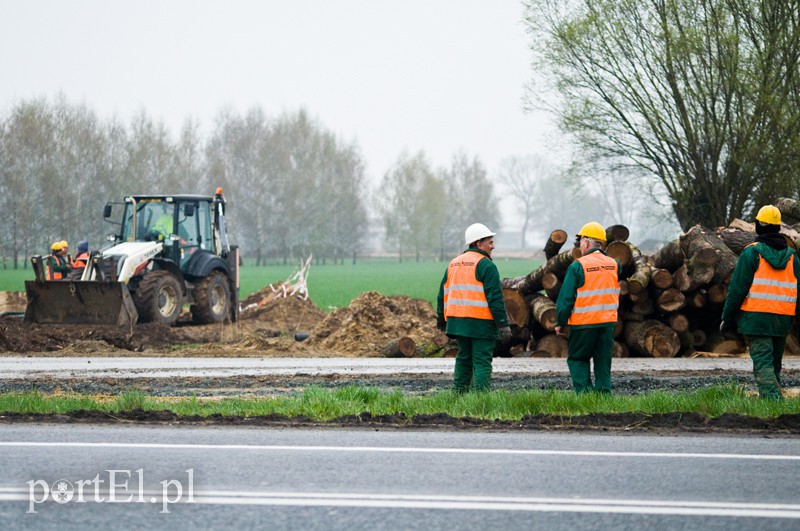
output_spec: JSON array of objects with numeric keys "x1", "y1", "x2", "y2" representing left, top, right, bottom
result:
[{"x1": 444, "y1": 251, "x2": 494, "y2": 320}]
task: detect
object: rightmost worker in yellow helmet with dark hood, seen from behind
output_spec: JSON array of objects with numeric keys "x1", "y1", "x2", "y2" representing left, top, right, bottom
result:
[{"x1": 719, "y1": 205, "x2": 800, "y2": 400}]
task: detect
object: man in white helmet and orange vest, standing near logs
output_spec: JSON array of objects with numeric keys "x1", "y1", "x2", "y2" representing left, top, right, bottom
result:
[{"x1": 436, "y1": 223, "x2": 511, "y2": 393}]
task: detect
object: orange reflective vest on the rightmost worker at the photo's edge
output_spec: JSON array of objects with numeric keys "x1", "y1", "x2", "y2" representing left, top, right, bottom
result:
[{"x1": 740, "y1": 253, "x2": 797, "y2": 315}]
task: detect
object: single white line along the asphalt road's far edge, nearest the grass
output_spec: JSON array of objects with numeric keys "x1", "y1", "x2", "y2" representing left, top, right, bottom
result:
[{"x1": 0, "y1": 441, "x2": 800, "y2": 461}]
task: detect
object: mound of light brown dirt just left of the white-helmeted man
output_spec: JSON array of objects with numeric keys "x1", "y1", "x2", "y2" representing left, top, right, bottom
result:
[{"x1": 308, "y1": 291, "x2": 437, "y2": 357}]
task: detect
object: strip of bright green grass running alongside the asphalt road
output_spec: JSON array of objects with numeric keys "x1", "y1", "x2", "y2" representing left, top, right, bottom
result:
[{"x1": 0, "y1": 383, "x2": 800, "y2": 421}]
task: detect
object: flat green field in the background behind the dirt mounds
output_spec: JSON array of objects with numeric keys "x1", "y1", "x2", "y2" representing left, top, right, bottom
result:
[{"x1": 0, "y1": 258, "x2": 542, "y2": 311}]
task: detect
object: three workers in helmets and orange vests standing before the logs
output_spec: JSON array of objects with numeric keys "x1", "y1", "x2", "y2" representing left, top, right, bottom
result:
[{"x1": 437, "y1": 205, "x2": 800, "y2": 400}]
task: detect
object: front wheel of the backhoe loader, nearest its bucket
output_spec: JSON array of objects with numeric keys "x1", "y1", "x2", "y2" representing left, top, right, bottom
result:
[{"x1": 133, "y1": 270, "x2": 183, "y2": 326}]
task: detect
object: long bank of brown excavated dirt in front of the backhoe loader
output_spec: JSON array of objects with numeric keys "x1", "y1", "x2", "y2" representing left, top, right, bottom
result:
[{"x1": 0, "y1": 286, "x2": 436, "y2": 357}]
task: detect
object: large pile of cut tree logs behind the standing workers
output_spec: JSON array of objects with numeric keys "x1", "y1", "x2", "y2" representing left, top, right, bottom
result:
[{"x1": 496, "y1": 199, "x2": 800, "y2": 358}]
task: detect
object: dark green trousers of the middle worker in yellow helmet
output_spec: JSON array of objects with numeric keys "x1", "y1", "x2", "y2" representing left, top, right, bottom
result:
[{"x1": 567, "y1": 325, "x2": 614, "y2": 394}]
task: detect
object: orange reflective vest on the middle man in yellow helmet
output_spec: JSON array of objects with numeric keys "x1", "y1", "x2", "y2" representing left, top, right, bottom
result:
[{"x1": 567, "y1": 252, "x2": 619, "y2": 325}]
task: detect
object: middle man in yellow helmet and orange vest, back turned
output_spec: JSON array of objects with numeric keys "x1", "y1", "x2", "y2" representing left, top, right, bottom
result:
[{"x1": 555, "y1": 221, "x2": 621, "y2": 394}]
